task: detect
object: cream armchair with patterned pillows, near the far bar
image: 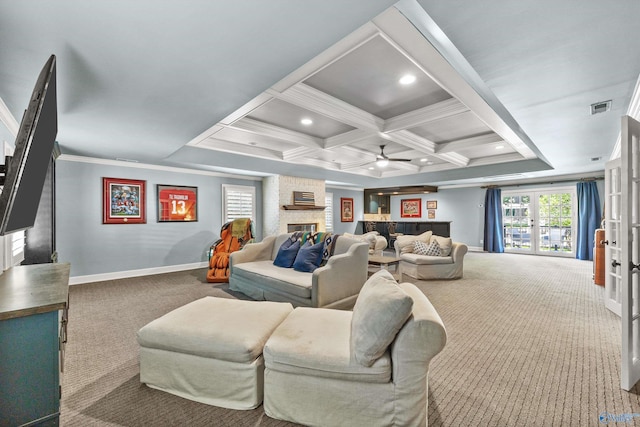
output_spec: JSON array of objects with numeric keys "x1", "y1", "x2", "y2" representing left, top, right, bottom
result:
[{"x1": 394, "y1": 231, "x2": 468, "y2": 280}]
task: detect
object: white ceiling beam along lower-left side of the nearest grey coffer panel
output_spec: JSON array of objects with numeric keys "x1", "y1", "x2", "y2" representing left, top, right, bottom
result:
[{"x1": 267, "y1": 83, "x2": 384, "y2": 132}]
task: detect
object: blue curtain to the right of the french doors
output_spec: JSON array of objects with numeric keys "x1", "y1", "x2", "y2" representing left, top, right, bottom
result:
[{"x1": 576, "y1": 181, "x2": 602, "y2": 260}]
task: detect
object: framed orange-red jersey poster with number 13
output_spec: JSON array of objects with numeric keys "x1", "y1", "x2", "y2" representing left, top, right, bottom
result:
[{"x1": 157, "y1": 184, "x2": 198, "y2": 222}]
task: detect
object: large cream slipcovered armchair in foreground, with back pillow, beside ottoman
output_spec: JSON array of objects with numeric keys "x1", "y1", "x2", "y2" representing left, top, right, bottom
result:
[{"x1": 263, "y1": 270, "x2": 446, "y2": 427}]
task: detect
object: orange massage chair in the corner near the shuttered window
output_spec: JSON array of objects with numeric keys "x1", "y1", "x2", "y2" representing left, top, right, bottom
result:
[{"x1": 207, "y1": 218, "x2": 253, "y2": 283}]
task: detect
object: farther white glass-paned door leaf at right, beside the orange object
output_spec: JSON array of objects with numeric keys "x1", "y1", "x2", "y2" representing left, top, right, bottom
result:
[{"x1": 604, "y1": 159, "x2": 622, "y2": 316}]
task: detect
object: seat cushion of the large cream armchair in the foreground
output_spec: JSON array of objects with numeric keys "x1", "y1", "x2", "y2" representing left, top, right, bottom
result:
[{"x1": 264, "y1": 307, "x2": 391, "y2": 383}]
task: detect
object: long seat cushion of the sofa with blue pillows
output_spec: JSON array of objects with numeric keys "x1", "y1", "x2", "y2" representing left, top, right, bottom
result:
[{"x1": 233, "y1": 260, "x2": 313, "y2": 298}]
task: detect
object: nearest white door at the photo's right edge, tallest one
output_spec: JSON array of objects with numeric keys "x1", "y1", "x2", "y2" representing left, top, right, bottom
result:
[{"x1": 620, "y1": 116, "x2": 640, "y2": 390}]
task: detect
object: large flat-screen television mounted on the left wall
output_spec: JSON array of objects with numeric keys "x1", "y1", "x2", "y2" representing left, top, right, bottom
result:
[{"x1": 0, "y1": 55, "x2": 58, "y2": 236}]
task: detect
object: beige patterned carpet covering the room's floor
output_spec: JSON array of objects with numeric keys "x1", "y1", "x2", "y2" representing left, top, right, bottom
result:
[{"x1": 61, "y1": 252, "x2": 640, "y2": 426}]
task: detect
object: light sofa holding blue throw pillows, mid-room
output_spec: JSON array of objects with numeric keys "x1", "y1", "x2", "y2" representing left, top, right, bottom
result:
[{"x1": 229, "y1": 233, "x2": 368, "y2": 309}]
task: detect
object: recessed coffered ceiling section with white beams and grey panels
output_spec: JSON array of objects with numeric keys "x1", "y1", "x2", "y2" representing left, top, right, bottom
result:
[{"x1": 189, "y1": 8, "x2": 544, "y2": 182}]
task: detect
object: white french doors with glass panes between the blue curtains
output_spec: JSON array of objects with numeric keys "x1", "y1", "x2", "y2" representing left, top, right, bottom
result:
[{"x1": 502, "y1": 187, "x2": 577, "y2": 257}]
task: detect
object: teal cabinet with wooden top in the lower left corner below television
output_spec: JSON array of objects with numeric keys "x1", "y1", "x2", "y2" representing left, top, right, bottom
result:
[{"x1": 0, "y1": 263, "x2": 70, "y2": 426}]
